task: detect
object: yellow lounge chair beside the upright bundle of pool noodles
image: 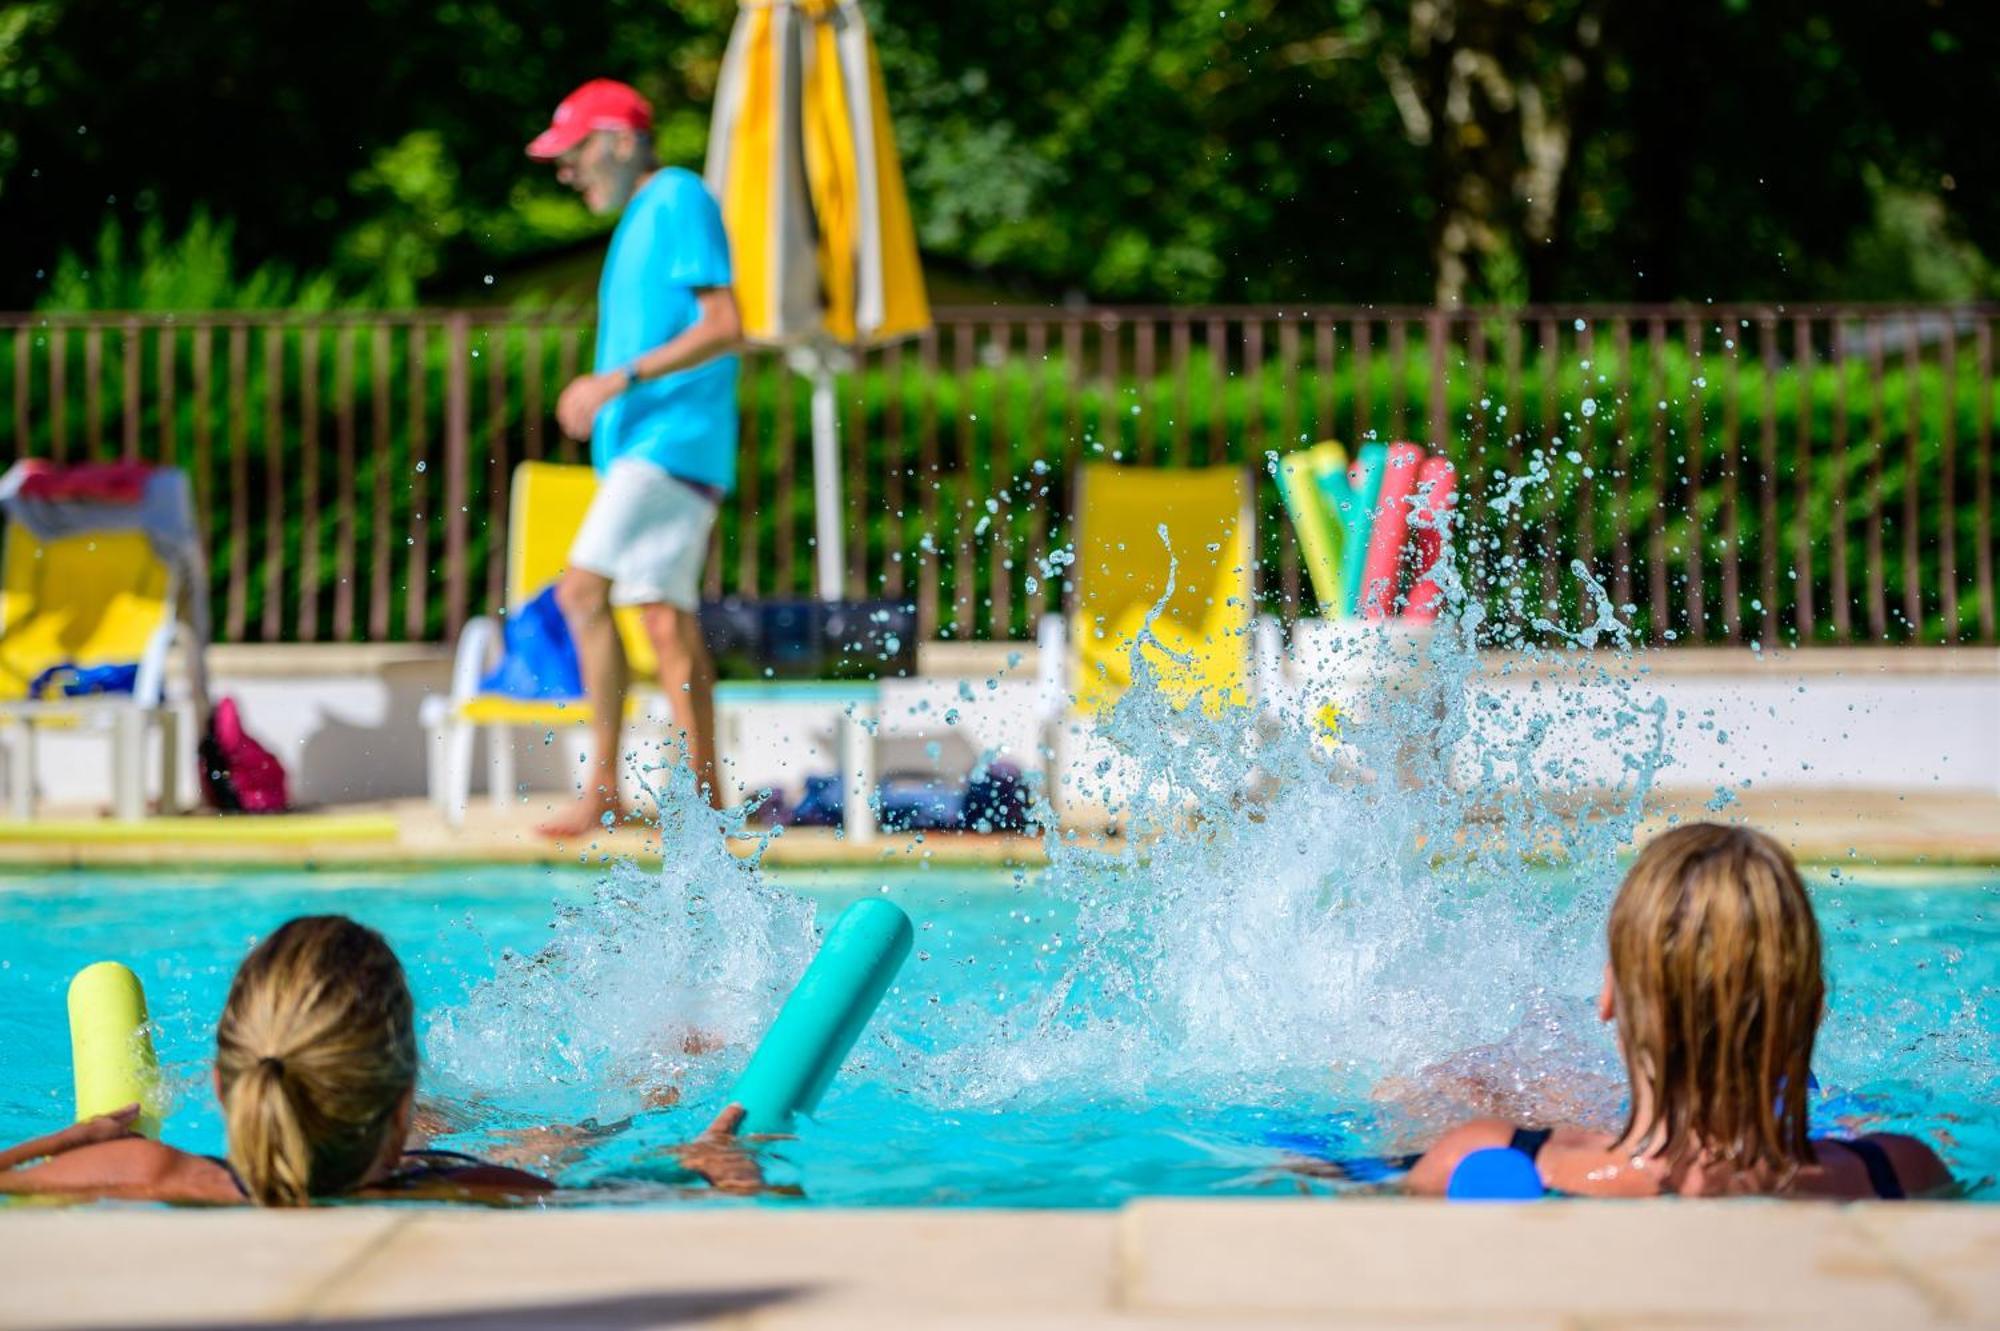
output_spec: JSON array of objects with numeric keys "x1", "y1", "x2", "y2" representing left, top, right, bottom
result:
[{"x1": 1038, "y1": 464, "x2": 1280, "y2": 805}]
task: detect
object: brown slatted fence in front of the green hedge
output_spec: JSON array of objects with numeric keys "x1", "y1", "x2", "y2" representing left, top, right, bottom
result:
[{"x1": 0, "y1": 304, "x2": 2000, "y2": 644}]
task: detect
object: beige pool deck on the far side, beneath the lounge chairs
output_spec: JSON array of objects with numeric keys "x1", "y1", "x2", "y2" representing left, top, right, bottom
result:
[{"x1": 0, "y1": 787, "x2": 2000, "y2": 871}]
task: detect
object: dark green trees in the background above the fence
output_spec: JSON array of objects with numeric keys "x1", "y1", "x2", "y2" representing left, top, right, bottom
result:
[{"x1": 0, "y1": 0, "x2": 2000, "y2": 308}]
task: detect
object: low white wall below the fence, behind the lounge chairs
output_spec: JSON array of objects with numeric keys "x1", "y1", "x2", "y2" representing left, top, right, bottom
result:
[{"x1": 6, "y1": 644, "x2": 2000, "y2": 805}]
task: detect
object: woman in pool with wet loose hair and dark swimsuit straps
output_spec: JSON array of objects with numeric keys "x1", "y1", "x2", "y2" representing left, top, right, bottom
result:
[{"x1": 1408, "y1": 823, "x2": 1952, "y2": 1199}]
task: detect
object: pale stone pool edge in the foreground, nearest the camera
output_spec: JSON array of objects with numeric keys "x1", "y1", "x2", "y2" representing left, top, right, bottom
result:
[{"x1": 0, "y1": 1199, "x2": 2000, "y2": 1331}]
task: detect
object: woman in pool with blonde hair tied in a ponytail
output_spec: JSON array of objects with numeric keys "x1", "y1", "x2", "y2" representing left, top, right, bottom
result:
[{"x1": 0, "y1": 915, "x2": 762, "y2": 1207}]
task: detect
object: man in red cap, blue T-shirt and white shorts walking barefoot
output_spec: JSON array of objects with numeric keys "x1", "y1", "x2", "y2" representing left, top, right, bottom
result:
[{"x1": 528, "y1": 78, "x2": 742, "y2": 837}]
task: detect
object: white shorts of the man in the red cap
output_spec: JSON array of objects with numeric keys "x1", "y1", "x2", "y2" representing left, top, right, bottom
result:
[{"x1": 570, "y1": 458, "x2": 716, "y2": 610}]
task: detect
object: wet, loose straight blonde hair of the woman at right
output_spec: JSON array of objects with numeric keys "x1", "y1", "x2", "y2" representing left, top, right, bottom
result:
[{"x1": 1610, "y1": 823, "x2": 1826, "y2": 1183}]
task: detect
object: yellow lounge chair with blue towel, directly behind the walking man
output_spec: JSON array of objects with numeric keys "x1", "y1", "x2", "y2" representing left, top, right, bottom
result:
[{"x1": 422, "y1": 462, "x2": 666, "y2": 827}]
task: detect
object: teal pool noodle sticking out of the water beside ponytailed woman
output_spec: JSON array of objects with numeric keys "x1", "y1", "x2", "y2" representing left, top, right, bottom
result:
[{"x1": 730, "y1": 897, "x2": 916, "y2": 1133}]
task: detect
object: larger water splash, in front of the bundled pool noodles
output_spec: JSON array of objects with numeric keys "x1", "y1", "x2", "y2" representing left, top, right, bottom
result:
[{"x1": 922, "y1": 496, "x2": 1668, "y2": 1115}]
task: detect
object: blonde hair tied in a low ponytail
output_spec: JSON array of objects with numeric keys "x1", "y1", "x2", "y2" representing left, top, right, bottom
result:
[{"x1": 216, "y1": 915, "x2": 416, "y2": 1207}]
